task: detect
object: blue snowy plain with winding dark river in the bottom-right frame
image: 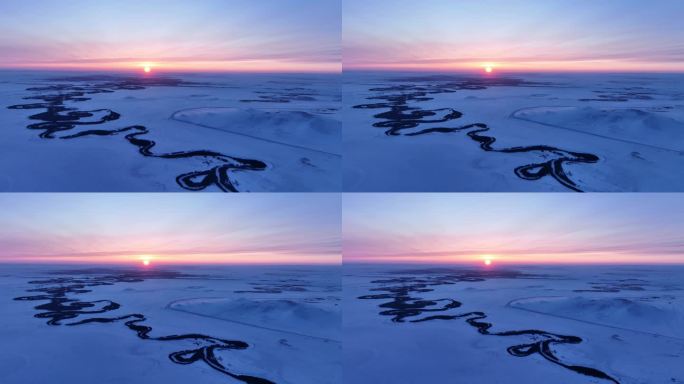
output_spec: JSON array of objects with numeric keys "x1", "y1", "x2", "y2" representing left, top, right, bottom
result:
[{"x1": 343, "y1": 264, "x2": 684, "y2": 384}]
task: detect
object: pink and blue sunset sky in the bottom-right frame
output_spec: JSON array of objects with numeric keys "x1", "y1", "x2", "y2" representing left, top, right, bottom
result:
[{"x1": 342, "y1": 193, "x2": 684, "y2": 265}]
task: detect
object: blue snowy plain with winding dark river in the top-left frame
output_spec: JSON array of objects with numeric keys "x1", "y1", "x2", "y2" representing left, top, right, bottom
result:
[{"x1": 0, "y1": 71, "x2": 342, "y2": 192}]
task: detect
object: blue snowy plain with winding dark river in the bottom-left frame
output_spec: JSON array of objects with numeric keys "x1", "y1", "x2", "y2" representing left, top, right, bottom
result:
[{"x1": 0, "y1": 265, "x2": 342, "y2": 384}]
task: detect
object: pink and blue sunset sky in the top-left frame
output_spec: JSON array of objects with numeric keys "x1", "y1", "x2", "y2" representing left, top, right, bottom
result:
[{"x1": 0, "y1": 0, "x2": 341, "y2": 72}]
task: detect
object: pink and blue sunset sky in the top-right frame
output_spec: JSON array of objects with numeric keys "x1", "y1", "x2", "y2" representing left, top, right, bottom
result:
[{"x1": 343, "y1": 0, "x2": 684, "y2": 72}]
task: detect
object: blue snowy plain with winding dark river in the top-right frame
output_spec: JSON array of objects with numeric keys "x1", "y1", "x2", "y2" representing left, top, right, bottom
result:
[{"x1": 342, "y1": 72, "x2": 684, "y2": 192}]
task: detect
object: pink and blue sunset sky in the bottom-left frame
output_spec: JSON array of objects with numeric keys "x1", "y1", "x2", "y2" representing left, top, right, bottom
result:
[{"x1": 0, "y1": 193, "x2": 341, "y2": 264}]
